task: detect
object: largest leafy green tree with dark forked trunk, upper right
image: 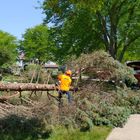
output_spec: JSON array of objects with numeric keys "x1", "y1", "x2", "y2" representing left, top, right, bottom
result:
[{"x1": 43, "y1": 0, "x2": 140, "y2": 61}]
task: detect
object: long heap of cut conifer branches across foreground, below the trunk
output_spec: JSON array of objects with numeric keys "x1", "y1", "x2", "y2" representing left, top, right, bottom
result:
[{"x1": 0, "y1": 80, "x2": 140, "y2": 132}]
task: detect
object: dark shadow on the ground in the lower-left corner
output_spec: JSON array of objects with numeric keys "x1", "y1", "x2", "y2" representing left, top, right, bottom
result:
[{"x1": 0, "y1": 115, "x2": 51, "y2": 140}]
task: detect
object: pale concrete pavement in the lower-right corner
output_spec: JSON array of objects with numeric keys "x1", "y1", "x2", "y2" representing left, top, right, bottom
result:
[{"x1": 106, "y1": 114, "x2": 140, "y2": 140}]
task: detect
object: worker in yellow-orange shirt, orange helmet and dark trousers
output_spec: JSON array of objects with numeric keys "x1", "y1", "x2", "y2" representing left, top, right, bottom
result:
[{"x1": 58, "y1": 70, "x2": 72, "y2": 103}]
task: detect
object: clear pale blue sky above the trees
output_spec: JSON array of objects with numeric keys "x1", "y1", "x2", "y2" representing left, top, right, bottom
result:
[{"x1": 0, "y1": 0, "x2": 45, "y2": 39}]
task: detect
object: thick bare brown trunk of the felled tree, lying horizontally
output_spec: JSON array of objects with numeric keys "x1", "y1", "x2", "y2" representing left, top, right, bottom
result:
[{"x1": 0, "y1": 83, "x2": 56, "y2": 91}]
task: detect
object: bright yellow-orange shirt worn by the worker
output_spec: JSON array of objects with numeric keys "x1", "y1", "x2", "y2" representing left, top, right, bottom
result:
[{"x1": 58, "y1": 74, "x2": 72, "y2": 91}]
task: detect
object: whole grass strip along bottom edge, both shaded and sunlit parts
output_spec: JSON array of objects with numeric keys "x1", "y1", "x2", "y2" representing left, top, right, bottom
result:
[{"x1": 0, "y1": 126, "x2": 111, "y2": 140}]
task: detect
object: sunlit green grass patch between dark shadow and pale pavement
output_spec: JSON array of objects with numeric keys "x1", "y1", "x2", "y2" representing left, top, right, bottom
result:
[{"x1": 48, "y1": 126, "x2": 111, "y2": 140}]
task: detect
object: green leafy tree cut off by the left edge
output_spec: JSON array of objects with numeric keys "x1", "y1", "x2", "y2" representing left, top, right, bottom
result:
[{"x1": 0, "y1": 31, "x2": 17, "y2": 66}]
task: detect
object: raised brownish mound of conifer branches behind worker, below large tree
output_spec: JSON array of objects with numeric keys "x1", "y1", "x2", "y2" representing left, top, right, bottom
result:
[{"x1": 67, "y1": 50, "x2": 137, "y2": 83}]
